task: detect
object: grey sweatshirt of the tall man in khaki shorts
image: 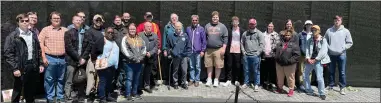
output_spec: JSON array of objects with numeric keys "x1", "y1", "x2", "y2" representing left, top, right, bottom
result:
[{"x1": 205, "y1": 22, "x2": 228, "y2": 49}]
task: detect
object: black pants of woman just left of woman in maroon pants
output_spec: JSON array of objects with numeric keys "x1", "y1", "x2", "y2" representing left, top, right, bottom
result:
[{"x1": 260, "y1": 57, "x2": 277, "y2": 87}]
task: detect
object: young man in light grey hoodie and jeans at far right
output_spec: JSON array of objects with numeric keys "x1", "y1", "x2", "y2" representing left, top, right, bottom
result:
[{"x1": 324, "y1": 15, "x2": 353, "y2": 95}]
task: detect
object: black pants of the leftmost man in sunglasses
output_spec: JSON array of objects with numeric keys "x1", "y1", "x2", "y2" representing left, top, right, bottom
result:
[{"x1": 12, "y1": 63, "x2": 39, "y2": 103}]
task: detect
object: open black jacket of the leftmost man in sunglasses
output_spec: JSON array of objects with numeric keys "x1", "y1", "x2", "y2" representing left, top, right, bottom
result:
[{"x1": 4, "y1": 28, "x2": 42, "y2": 73}]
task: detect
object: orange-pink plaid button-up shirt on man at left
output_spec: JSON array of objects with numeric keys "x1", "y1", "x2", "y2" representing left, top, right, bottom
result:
[{"x1": 38, "y1": 25, "x2": 67, "y2": 56}]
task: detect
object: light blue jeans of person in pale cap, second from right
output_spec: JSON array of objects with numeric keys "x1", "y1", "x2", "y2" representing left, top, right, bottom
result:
[{"x1": 303, "y1": 61, "x2": 325, "y2": 95}]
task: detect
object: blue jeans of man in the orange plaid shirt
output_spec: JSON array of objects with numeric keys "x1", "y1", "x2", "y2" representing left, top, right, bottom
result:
[{"x1": 44, "y1": 55, "x2": 66, "y2": 101}]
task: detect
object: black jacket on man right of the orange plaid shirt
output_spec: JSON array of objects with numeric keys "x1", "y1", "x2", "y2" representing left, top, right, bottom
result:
[{"x1": 64, "y1": 28, "x2": 88, "y2": 66}]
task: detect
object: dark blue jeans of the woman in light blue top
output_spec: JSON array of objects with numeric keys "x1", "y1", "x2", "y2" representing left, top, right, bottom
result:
[{"x1": 97, "y1": 66, "x2": 115, "y2": 100}]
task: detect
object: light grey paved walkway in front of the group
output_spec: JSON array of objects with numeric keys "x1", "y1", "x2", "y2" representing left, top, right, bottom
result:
[{"x1": 118, "y1": 84, "x2": 380, "y2": 102}]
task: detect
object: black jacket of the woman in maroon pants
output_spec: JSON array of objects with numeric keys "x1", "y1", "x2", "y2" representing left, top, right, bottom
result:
[{"x1": 275, "y1": 35, "x2": 300, "y2": 66}]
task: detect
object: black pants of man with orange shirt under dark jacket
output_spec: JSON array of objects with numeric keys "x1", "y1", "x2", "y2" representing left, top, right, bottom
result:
[{"x1": 143, "y1": 55, "x2": 157, "y2": 87}]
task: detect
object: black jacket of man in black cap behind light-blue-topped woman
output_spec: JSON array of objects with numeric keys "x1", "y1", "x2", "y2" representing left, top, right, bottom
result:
[{"x1": 82, "y1": 25, "x2": 104, "y2": 60}]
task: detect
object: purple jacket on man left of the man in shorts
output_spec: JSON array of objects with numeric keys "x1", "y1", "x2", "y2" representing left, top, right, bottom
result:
[{"x1": 186, "y1": 24, "x2": 206, "y2": 53}]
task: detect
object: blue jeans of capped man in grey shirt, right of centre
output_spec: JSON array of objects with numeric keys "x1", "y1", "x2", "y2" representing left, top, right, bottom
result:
[{"x1": 244, "y1": 56, "x2": 261, "y2": 85}]
